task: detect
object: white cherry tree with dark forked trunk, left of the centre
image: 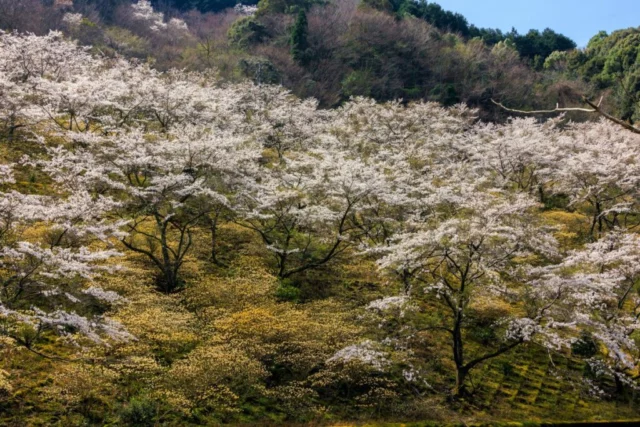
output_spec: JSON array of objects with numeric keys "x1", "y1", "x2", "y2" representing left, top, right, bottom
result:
[{"x1": 43, "y1": 127, "x2": 258, "y2": 293}]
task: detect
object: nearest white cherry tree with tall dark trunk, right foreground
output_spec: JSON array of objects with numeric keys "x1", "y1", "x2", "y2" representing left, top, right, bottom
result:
[{"x1": 378, "y1": 188, "x2": 556, "y2": 396}]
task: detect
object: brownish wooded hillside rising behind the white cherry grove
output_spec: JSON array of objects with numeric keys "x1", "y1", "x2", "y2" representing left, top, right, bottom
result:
[{"x1": 0, "y1": 0, "x2": 595, "y2": 115}]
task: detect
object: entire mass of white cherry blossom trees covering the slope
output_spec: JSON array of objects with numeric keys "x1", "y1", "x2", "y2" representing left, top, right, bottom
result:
[{"x1": 0, "y1": 30, "x2": 640, "y2": 392}]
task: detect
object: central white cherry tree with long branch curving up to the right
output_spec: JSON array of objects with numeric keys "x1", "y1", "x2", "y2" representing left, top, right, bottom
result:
[{"x1": 239, "y1": 150, "x2": 388, "y2": 278}]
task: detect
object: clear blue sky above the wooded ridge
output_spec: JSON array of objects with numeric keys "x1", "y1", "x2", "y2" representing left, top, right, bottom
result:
[{"x1": 435, "y1": 0, "x2": 640, "y2": 47}]
